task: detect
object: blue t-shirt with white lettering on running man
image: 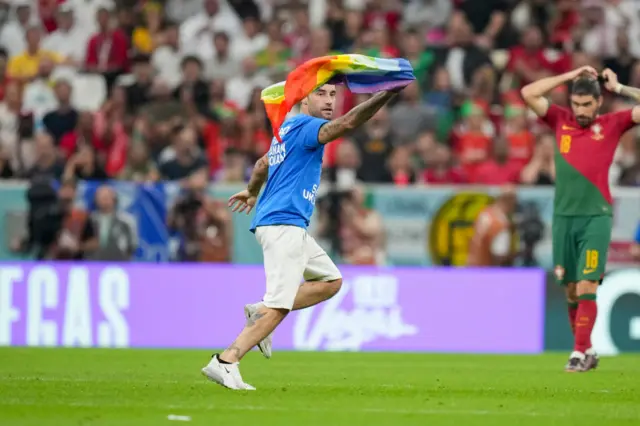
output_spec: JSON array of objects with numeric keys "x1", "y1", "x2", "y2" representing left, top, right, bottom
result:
[{"x1": 251, "y1": 114, "x2": 327, "y2": 232}]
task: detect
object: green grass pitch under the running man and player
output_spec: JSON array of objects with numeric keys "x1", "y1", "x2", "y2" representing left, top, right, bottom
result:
[{"x1": 0, "y1": 348, "x2": 640, "y2": 426}]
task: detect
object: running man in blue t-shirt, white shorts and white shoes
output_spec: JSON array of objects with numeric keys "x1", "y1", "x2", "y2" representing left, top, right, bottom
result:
[{"x1": 202, "y1": 84, "x2": 399, "y2": 390}]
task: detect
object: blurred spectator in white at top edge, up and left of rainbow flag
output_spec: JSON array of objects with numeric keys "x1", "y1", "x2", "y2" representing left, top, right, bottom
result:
[{"x1": 181, "y1": 0, "x2": 242, "y2": 59}]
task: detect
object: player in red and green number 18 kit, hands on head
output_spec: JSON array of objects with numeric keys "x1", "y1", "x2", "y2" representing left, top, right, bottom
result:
[{"x1": 522, "y1": 66, "x2": 640, "y2": 372}]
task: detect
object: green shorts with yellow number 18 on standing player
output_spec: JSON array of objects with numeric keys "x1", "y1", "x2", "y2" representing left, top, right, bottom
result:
[{"x1": 551, "y1": 215, "x2": 613, "y2": 285}]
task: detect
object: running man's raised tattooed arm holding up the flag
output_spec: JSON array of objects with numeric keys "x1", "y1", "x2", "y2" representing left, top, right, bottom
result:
[{"x1": 318, "y1": 91, "x2": 397, "y2": 144}]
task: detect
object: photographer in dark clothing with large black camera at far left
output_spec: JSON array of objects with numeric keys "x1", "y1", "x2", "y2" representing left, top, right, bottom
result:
[{"x1": 11, "y1": 177, "x2": 98, "y2": 260}]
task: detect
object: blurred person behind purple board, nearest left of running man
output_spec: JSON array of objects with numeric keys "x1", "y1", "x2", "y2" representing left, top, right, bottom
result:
[{"x1": 167, "y1": 171, "x2": 232, "y2": 262}]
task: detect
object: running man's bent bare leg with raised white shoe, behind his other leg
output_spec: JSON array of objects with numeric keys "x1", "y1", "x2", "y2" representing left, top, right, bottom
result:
[{"x1": 244, "y1": 278, "x2": 342, "y2": 358}]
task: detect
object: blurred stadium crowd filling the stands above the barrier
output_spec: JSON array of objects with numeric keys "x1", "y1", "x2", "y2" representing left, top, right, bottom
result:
[{"x1": 0, "y1": 0, "x2": 640, "y2": 190}]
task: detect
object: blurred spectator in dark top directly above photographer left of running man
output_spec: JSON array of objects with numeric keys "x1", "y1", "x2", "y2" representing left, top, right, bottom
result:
[{"x1": 159, "y1": 126, "x2": 208, "y2": 180}]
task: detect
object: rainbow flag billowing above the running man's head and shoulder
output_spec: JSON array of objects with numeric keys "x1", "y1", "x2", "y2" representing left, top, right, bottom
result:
[{"x1": 261, "y1": 54, "x2": 416, "y2": 142}]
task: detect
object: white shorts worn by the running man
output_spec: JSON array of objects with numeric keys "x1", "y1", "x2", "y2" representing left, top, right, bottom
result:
[{"x1": 256, "y1": 225, "x2": 342, "y2": 310}]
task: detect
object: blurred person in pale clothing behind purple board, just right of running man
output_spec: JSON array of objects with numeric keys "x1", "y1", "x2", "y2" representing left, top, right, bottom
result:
[{"x1": 338, "y1": 185, "x2": 386, "y2": 265}]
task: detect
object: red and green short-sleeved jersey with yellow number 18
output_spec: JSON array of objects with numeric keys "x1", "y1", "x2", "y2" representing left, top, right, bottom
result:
[{"x1": 542, "y1": 105, "x2": 635, "y2": 216}]
